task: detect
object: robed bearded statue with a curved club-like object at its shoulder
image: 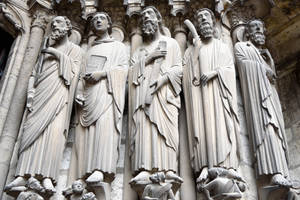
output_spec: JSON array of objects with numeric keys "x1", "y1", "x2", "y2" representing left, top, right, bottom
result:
[{"x1": 183, "y1": 8, "x2": 239, "y2": 188}]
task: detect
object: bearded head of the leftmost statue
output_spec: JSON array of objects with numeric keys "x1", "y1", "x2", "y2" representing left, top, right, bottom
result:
[{"x1": 50, "y1": 16, "x2": 72, "y2": 41}]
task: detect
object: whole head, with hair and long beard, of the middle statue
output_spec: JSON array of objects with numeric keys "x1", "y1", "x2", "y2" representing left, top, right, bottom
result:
[{"x1": 141, "y1": 6, "x2": 162, "y2": 38}]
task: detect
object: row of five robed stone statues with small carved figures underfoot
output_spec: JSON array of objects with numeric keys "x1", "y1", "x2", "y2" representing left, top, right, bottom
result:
[{"x1": 5, "y1": 6, "x2": 291, "y2": 200}]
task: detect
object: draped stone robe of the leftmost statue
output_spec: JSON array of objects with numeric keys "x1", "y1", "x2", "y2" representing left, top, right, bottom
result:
[{"x1": 16, "y1": 42, "x2": 82, "y2": 183}]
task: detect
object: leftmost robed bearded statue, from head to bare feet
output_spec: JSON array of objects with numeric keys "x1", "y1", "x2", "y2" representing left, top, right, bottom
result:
[{"x1": 5, "y1": 16, "x2": 82, "y2": 194}]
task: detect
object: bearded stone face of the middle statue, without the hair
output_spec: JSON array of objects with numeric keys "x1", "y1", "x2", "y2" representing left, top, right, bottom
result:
[{"x1": 141, "y1": 8, "x2": 159, "y2": 36}]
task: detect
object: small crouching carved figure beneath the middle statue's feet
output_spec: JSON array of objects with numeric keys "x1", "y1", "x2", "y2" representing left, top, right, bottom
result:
[{"x1": 142, "y1": 172, "x2": 175, "y2": 200}]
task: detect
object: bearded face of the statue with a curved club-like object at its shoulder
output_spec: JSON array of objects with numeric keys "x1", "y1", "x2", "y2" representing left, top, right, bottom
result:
[{"x1": 197, "y1": 10, "x2": 214, "y2": 39}]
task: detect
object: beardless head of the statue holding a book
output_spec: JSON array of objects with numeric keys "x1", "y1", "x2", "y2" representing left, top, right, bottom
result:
[{"x1": 91, "y1": 12, "x2": 112, "y2": 34}]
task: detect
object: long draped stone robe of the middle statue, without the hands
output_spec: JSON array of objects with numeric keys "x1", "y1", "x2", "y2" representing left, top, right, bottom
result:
[{"x1": 129, "y1": 36, "x2": 182, "y2": 172}]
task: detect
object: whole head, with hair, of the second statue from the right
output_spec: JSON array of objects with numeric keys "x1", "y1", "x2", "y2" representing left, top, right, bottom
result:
[{"x1": 195, "y1": 8, "x2": 216, "y2": 40}]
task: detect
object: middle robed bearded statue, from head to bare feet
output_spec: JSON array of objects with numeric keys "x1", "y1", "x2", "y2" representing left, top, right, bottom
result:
[{"x1": 129, "y1": 7, "x2": 182, "y2": 183}]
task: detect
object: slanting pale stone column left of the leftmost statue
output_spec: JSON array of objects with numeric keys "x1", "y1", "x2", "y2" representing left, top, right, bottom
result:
[{"x1": 0, "y1": 9, "x2": 49, "y2": 197}]
